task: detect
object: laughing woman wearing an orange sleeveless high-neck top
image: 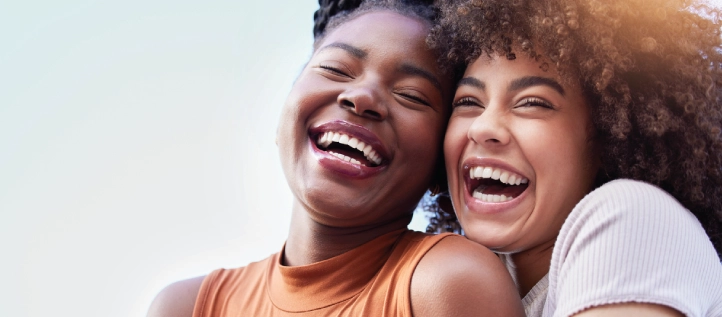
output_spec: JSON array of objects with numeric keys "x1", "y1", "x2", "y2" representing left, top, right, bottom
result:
[{"x1": 148, "y1": 0, "x2": 523, "y2": 317}]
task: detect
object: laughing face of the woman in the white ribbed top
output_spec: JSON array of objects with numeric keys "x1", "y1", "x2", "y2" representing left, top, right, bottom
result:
[{"x1": 444, "y1": 56, "x2": 597, "y2": 252}]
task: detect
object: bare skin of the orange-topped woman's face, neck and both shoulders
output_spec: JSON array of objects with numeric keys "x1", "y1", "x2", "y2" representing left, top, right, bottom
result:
[{"x1": 148, "y1": 11, "x2": 523, "y2": 316}]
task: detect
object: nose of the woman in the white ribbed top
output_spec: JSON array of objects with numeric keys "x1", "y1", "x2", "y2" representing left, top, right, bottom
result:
[{"x1": 467, "y1": 107, "x2": 511, "y2": 148}]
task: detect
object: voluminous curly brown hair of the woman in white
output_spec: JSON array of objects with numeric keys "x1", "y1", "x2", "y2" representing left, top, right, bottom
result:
[{"x1": 428, "y1": 0, "x2": 722, "y2": 254}]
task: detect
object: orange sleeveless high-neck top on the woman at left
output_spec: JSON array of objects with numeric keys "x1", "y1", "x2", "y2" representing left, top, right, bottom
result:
[{"x1": 193, "y1": 230, "x2": 450, "y2": 317}]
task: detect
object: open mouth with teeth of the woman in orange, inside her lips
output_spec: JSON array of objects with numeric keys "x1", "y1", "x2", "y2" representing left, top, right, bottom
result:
[{"x1": 316, "y1": 131, "x2": 384, "y2": 167}]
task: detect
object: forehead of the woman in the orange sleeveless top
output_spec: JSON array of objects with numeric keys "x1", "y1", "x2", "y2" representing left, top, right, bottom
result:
[{"x1": 319, "y1": 11, "x2": 435, "y2": 62}]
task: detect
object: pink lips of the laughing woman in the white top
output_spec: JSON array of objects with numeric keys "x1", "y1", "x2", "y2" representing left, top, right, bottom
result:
[{"x1": 459, "y1": 158, "x2": 532, "y2": 214}]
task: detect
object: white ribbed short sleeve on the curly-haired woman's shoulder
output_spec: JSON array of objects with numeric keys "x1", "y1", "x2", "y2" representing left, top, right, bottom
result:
[{"x1": 544, "y1": 180, "x2": 722, "y2": 316}]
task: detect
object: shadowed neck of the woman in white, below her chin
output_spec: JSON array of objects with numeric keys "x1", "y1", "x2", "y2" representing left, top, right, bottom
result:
[{"x1": 510, "y1": 240, "x2": 554, "y2": 298}]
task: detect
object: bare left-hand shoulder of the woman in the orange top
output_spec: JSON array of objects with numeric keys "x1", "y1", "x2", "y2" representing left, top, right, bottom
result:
[{"x1": 147, "y1": 276, "x2": 205, "y2": 317}]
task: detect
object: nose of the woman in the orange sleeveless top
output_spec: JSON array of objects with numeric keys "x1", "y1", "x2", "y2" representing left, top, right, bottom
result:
[{"x1": 338, "y1": 82, "x2": 388, "y2": 120}]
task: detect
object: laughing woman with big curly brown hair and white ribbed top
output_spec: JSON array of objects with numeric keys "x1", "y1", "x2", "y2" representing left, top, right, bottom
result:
[{"x1": 429, "y1": 0, "x2": 722, "y2": 316}]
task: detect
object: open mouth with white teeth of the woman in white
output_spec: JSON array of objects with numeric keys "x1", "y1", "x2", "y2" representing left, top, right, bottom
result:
[{"x1": 467, "y1": 166, "x2": 529, "y2": 203}]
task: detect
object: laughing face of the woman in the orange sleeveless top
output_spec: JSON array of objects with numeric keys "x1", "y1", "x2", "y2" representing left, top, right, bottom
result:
[{"x1": 278, "y1": 11, "x2": 451, "y2": 227}]
